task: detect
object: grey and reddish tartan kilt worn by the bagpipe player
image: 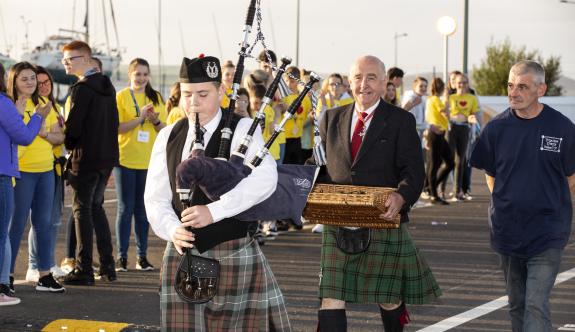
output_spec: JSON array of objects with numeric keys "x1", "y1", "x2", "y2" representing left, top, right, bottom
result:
[{"x1": 160, "y1": 237, "x2": 291, "y2": 332}]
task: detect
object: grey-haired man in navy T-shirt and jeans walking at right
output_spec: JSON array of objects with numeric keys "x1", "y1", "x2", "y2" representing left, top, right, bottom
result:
[{"x1": 471, "y1": 61, "x2": 575, "y2": 332}]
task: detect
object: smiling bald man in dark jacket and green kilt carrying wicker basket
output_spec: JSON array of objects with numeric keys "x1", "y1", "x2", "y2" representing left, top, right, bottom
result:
[{"x1": 318, "y1": 56, "x2": 441, "y2": 332}]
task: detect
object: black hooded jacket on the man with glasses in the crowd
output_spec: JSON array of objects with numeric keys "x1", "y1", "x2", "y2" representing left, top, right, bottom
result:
[{"x1": 64, "y1": 73, "x2": 119, "y2": 174}]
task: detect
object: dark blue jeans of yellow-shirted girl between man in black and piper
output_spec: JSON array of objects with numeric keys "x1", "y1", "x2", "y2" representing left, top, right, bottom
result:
[{"x1": 114, "y1": 166, "x2": 150, "y2": 258}]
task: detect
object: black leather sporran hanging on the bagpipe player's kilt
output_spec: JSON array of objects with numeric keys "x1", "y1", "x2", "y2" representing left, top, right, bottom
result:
[{"x1": 174, "y1": 253, "x2": 220, "y2": 304}]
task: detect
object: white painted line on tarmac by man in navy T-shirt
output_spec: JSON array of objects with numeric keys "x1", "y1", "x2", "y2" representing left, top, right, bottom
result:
[{"x1": 418, "y1": 268, "x2": 575, "y2": 332}]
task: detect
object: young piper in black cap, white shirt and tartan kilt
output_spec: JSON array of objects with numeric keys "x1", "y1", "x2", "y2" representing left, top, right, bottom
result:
[{"x1": 144, "y1": 55, "x2": 291, "y2": 331}]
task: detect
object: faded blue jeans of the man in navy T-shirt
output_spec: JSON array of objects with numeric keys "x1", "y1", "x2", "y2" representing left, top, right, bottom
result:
[{"x1": 500, "y1": 248, "x2": 563, "y2": 332}]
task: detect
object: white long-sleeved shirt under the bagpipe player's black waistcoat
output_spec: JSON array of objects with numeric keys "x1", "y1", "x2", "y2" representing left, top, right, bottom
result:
[{"x1": 144, "y1": 110, "x2": 277, "y2": 241}]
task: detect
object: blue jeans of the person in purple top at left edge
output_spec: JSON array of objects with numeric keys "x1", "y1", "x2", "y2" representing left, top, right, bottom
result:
[{"x1": 0, "y1": 175, "x2": 14, "y2": 284}]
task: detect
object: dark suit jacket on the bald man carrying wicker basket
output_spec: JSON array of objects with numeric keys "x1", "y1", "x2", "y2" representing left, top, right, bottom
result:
[{"x1": 318, "y1": 99, "x2": 425, "y2": 222}]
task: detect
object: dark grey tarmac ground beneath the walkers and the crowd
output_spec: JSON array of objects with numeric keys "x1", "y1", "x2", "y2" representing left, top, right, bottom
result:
[{"x1": 0, "y1": 171, "x2": 575, "y2": 332}]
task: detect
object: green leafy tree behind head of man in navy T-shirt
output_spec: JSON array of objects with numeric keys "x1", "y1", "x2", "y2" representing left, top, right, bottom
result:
[{"x1": 472, "y1": 39, "x2": 563, "y2": 96}]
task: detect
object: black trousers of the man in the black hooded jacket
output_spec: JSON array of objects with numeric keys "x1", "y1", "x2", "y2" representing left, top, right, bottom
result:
[{"x1": 68, "y1": 169, "x2": 114, "y2": 273}]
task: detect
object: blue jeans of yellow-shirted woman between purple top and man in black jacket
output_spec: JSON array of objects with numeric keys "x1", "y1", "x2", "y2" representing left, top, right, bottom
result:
[{"x1": 10, "y1": 171, "x2": 54, "y2": 273}]
